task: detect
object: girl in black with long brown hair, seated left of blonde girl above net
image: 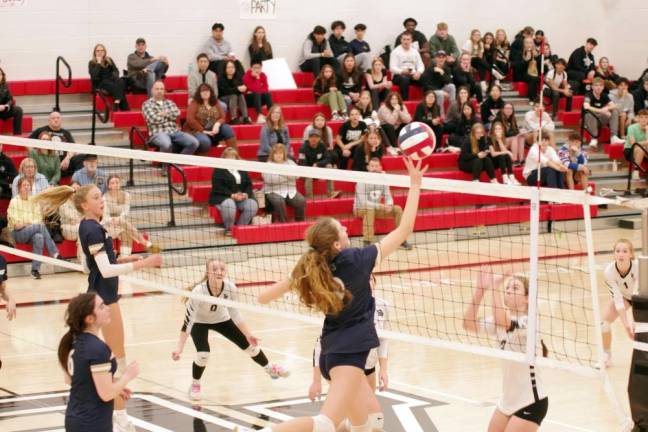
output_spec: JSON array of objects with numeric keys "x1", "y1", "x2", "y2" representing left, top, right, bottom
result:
[{"x1": 458, "y1": 123, "x2": 498, "y2": 183}]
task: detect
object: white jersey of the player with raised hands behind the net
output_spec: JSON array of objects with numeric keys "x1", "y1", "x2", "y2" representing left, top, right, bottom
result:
[{"x1": 482, "y1": 316, "x2": 547, "y2": 416}]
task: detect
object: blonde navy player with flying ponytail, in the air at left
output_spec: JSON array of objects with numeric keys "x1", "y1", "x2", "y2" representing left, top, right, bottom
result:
[{"x1": 34, "y1": 185, "x2": 162, "y2": 432}]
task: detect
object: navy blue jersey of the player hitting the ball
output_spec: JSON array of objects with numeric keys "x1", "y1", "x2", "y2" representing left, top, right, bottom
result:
[{"x1": 322, "y1": 244, "x2": 380, "y2": 354}]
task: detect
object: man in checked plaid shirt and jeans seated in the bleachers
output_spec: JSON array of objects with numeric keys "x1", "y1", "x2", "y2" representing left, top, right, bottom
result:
[{"x1": 142, "y1": 81, "x2": 200, "y2": 154}]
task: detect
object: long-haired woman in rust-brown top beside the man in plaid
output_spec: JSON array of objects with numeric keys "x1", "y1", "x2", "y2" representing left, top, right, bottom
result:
[{"x1": 184, "y1": 84, "x2": 236, "y2": 153}]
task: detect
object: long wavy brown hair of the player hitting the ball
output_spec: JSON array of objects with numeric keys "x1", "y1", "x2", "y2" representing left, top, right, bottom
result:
[{"x1": 290, "y1": 218, "x2": 352, "y2": 315}]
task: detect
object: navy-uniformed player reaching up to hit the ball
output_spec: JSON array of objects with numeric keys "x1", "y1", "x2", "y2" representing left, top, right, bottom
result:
[{"x1": 258, "y1": 158, "x2": 427, "y2": 432}]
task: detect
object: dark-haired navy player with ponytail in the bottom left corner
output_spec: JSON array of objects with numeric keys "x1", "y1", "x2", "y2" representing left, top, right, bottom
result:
[{"x1": 58, "y1": 292, "x2": 139, "y2": 432}]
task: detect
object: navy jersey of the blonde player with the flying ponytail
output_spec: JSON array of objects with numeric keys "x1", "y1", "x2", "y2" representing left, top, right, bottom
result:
[{"x1": 79, "y1": 219, "x2": 119, "y2": 304}]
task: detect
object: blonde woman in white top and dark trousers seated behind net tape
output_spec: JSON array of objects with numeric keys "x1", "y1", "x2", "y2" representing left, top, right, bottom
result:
[{"x1": 263, "y1": 144, "x2": 306, "y2": 222}]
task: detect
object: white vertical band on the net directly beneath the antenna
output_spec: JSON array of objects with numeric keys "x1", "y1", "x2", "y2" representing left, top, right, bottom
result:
[{"x1": 526, "y1": 188, "x2": 540, "y2": 366}]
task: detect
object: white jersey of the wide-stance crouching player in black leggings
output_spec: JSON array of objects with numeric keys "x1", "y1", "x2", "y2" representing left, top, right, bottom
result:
[{"x1": 182, "y1": 279, "x2": 243, "y2": 333}]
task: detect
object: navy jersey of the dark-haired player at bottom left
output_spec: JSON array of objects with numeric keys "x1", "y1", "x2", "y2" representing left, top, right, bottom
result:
[{"x1": 65, "y1": 333, "x2": 117, "y2": 432}]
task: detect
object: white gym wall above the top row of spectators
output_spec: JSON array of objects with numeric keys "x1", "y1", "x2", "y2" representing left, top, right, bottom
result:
[{"x1": 0, "y1": 0, "x2": 648, "y2": 80}]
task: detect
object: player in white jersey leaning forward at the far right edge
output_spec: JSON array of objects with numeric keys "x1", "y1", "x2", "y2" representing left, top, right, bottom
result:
[{"x1": 601, "y1": 239, "x2": 639, "y2": 367}]
